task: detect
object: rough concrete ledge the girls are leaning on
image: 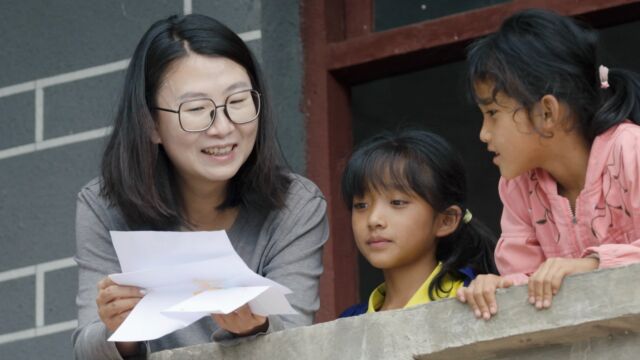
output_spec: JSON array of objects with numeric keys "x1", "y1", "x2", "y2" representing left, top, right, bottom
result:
[{"x1": 150, "y1": 264, "x2": 640, "y2": 360}]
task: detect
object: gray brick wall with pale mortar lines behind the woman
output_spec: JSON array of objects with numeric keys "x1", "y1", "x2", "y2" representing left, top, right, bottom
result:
[{"x1": 0, "y1": 0, "x2": 304, "y2": 359}]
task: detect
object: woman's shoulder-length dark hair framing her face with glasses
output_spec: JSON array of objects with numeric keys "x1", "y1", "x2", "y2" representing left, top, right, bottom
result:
[{"x1": 101, "y1": 15, "x2": 291, "y2": 229}]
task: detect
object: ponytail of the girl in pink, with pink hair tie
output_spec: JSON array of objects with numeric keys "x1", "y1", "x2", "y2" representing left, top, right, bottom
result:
[{"x1": 589, "y1": 69, "x2": 640, "y2": 139}]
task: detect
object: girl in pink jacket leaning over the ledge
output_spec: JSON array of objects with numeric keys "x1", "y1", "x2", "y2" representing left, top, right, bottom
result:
[{"x1": 457, "y1": 10, "x2": 640, "y2": 320}]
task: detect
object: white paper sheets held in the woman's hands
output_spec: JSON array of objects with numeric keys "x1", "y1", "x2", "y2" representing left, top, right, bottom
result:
[{"x1": 109, "y1": 231, "x2": 296, "y2": 341}]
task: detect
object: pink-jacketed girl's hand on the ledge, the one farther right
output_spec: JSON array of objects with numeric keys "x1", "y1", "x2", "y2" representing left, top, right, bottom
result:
[{"x1": 529, "y1": 257, "x2": 600, "y2": 309}]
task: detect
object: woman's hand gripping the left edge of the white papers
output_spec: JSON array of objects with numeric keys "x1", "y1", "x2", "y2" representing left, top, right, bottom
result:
[{"x1": 96, "y1": 277, "x2": 144, "y2": 356}]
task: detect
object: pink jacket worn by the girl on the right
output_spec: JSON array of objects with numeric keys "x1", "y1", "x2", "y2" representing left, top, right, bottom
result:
[{"x1": 495, "y1": 122, "x2": 640, "y2": 285}]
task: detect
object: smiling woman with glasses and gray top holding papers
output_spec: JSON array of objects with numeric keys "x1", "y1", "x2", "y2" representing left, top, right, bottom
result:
[{"x1": 73, "y1": 15, "x2": 328, "y2": 359}]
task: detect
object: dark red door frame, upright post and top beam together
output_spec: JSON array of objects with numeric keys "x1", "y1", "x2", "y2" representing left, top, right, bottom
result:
[{"x1": 301, "y1": 0, "x2": 640, "y2": 321}]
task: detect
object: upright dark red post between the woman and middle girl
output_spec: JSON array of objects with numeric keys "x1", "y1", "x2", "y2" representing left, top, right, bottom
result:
[{"x1": 302, "y1": 0, "x2": 358, "y2": 321}]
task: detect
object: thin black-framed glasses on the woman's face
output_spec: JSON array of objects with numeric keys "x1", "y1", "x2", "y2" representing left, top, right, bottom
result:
[{"x1": 153, "y1": 89, "x2": 261, "y2": 132}]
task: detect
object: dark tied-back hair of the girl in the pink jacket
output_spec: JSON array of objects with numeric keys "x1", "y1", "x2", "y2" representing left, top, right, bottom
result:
[{"x1": 467, "y1": 9, "x2": 640, "y2": 143}]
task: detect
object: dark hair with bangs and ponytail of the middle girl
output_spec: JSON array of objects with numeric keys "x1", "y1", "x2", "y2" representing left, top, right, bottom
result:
[{"x1": 342, "y1": 130, "x2": 498, "y2": 300}]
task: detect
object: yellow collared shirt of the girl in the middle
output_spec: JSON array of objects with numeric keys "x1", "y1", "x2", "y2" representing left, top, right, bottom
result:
[{"x1": 367, "y1": 262, "x2": 464, "y2": 313}]
